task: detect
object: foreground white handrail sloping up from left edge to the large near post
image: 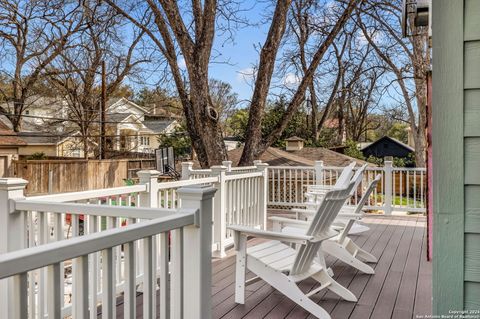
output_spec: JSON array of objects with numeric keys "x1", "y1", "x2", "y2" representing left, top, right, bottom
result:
[{"x1": 0, "y1": 209, "x2": 199, "y2": 279}]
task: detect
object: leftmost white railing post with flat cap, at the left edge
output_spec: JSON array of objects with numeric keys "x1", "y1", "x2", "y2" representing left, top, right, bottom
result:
[{"x1": 0, "y1": 178, "x2": 28, "y2": 318}]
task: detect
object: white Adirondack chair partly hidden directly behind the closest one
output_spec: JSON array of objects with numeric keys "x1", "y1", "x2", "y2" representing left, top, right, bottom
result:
[{"x1": 269, "y1": 174, "x2": 382, "y2": 274}]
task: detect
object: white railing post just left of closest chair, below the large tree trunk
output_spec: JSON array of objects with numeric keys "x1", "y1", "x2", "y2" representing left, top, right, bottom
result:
[{"x1": 211, "y1": 166, "x2": 227, "y2": 258}]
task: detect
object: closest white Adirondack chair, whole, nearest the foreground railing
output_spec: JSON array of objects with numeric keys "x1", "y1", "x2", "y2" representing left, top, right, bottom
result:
[{"x1": 228, "y1": 183, "x2": 357, "y2": 319}]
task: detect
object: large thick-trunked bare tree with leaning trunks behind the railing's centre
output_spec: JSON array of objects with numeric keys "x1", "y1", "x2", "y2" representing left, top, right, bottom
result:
[{"x1": 106, "y1": 0, "x2": 360, "y2": 166}]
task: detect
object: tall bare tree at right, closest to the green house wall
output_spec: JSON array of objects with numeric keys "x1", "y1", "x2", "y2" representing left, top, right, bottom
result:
[{"x1": 356, "y1": 0, "x2": 430, "y2": 167}]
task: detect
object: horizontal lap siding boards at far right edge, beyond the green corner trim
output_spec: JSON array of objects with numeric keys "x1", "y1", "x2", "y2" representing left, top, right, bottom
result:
[{"x1": 463, "y1": 0, "x2": 480, "y2": 310}]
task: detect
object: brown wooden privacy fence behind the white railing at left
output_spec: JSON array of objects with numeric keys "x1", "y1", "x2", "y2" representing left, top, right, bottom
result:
[{"x1": 11, "y1": 159, "x2": 155, "y2": 195}]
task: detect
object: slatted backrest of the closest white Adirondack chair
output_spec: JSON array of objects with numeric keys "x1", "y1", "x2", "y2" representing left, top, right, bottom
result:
[{"x1": 290, "y1": 181, "x2": 355, "y2": 275}]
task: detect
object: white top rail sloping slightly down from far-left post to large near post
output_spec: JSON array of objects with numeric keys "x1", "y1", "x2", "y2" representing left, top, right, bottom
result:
[{"x1": 13, "y1": 199, "x2": 176, "y2": 219}]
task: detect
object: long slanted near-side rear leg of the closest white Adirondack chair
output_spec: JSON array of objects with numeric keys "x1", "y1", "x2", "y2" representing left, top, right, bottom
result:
[{"x1": 248, "y1": 258, "x2": 331, "y2": 319}]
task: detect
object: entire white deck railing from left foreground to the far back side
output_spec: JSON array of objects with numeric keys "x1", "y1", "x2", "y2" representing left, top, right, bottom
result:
[{"x1": 0, "y1": 161, "x2": 426, "y2": 318}]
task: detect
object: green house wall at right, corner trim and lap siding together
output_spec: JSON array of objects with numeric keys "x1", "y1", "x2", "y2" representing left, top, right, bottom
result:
[{"x1": 432, "y1": 0, "x2": 480, "y2": 314}]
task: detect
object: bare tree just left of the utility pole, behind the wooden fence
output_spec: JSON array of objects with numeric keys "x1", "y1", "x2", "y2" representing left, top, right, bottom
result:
[{"x1": 45, "y1": 2, "x2": 149, "y2": 158}]
